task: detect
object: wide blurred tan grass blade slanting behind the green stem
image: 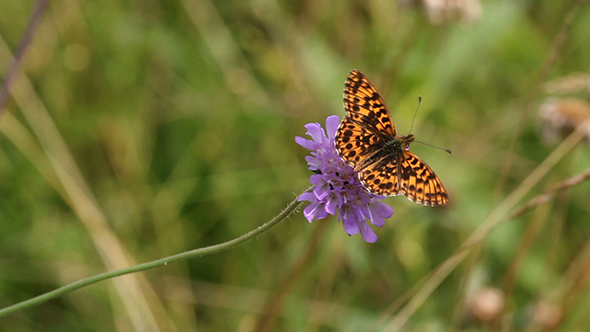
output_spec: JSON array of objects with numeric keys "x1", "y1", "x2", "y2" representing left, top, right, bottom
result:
[{"x1": 0, "y1": 35, "x2": 166, "y2": 331}]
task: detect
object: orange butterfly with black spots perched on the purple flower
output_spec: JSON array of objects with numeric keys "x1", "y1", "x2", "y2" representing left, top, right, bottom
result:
[{"x1": 335, "y1": 70, "x2": 449, "y2": 206}]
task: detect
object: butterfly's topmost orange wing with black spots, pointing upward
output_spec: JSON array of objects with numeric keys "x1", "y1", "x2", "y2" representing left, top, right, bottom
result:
[{"x1": 344, "y1": 70, "x2": 396, "y2": 137}]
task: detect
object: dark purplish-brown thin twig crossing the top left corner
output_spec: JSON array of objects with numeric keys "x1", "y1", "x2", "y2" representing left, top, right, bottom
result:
[{"x1": 0, "y1": 0, "x2": 49, "y2": 116}]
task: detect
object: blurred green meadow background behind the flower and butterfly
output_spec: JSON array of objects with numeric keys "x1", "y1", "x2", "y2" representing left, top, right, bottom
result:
[{"x1": 0, "y1": 0, "x2": 590, "y2": 331}]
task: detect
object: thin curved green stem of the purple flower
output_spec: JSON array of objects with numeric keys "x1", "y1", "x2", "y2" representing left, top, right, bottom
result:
[{"x1": 0, "y1": 187, "x2": 313, "y2": 317}]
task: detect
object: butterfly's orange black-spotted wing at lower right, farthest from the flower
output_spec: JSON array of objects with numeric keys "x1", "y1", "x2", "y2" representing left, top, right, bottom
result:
[{"x1": 399, "y1": 151, "x2": 449, "y2": 206}]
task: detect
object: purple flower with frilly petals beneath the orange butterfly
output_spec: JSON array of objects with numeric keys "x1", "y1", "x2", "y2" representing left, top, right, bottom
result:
[{"x1": 295, "y1": 115, "x2": 393, "y2": 243}]
